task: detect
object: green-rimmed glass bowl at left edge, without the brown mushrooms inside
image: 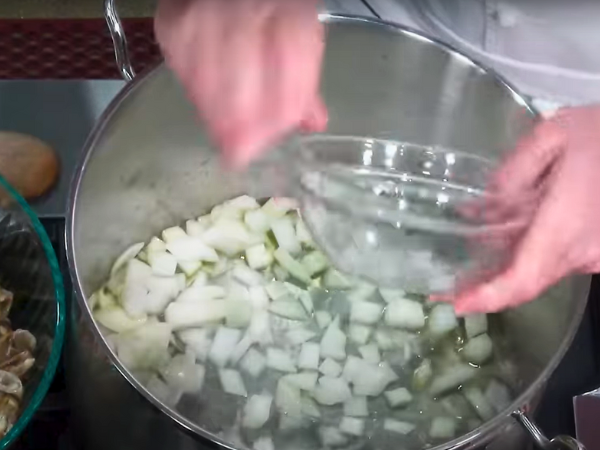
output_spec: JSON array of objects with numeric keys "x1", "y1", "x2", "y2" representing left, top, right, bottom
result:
[{"x1": 0, "y1": 177, "x2": 65, "y2": 449}]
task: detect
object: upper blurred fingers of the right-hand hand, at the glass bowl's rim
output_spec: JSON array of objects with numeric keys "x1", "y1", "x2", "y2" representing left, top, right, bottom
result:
[{"x1": 491, "y1": 114, "x2": 566, "y2": 194}]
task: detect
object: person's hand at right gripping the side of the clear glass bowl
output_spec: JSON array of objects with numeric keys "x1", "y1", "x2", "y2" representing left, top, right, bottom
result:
[{"x1": 454, "y1": 106, "x2": 600, "y2": 314}]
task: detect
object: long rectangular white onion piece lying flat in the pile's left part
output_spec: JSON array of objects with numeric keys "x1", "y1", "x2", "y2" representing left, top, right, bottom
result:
[{"x1": 165, "y1": 300, "x2": 228, "y2": 330}]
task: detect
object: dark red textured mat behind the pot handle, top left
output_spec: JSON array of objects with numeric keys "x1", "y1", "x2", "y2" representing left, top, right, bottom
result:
[{"x1": 0, "y1": 18, "x2": 160, "y2": 79}]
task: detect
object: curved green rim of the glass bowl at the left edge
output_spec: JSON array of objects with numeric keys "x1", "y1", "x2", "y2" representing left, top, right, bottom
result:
[{"x1": 0, "y1": 176, "x2": 66, "y2": 450}]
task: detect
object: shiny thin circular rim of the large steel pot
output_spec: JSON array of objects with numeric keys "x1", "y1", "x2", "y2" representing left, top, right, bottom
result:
[{"x1": 65, "y1": 13, "x2": 589, "y2": 450}]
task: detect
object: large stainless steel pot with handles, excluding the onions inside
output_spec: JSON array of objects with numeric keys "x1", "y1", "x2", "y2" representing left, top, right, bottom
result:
[{"x1": 67, "y1": 0, "x2": 589, "y2": 450}]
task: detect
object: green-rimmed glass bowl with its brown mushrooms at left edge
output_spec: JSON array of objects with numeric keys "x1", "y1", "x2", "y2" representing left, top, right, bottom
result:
[{"x1": 0, "y1": 177, "x2": 65, "y2": 444}]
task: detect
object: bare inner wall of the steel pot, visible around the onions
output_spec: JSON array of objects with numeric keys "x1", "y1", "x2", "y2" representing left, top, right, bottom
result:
[{"x1": 67, "y1": 16, "x2": 588, "y2": 450}]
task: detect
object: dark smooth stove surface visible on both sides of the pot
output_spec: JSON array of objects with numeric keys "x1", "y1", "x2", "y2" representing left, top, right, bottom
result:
[{"x1": 0, "y1": 80, "x2": 600, "y2": 450}]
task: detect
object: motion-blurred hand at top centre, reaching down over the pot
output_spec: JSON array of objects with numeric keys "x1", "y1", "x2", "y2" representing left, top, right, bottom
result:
[{"x1": 155, "y1": 0, "x2": 327, "y2": 167}]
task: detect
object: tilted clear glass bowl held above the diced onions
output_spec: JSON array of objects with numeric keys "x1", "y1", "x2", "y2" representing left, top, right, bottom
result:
[{"x1": 289, "y1": 135, "x2": 534, "y2": 294}]
